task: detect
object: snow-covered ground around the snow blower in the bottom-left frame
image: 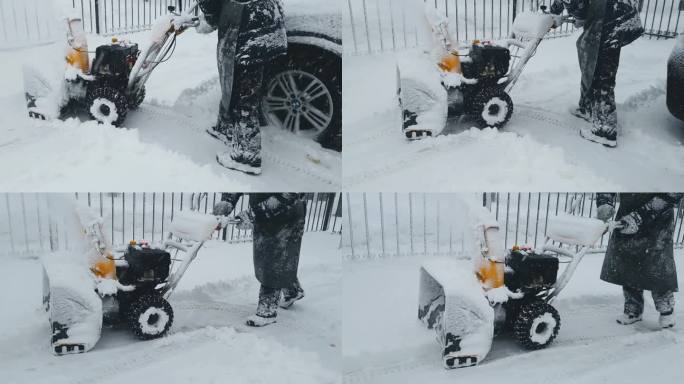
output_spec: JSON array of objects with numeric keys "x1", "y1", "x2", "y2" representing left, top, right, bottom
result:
[{"x1": 0, "y1": 232, "x2": 342, "y2": 383}]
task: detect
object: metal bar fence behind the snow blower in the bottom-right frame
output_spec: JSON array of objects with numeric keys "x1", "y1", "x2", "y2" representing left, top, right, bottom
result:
[{"x1": 343, "y1": 193, "x2": 684, "y2": 259}]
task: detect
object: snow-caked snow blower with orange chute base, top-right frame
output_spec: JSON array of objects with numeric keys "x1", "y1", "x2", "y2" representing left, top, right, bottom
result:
[{"x1": 397, "y1": 3, "x2": 572, "y2": 140}]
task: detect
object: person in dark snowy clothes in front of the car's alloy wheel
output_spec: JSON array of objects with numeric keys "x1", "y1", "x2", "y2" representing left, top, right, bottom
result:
[{"x1": 197, "y1": 0, "x2": 287, "y2": 175}]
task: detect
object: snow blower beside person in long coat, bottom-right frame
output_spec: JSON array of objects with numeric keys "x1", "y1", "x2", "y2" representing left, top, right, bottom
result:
[{"x1": 418, "y1": 215, "x2": 618, "y2": 368}]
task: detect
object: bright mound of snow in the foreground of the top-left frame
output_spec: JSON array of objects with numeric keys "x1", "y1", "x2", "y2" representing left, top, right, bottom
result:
[{"x1": 0, "y1": 119, "x2": 246, "y2": 192}]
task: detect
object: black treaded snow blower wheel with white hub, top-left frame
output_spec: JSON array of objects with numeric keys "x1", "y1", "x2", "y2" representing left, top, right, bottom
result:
[{"x1": 86, "y1": 86, "x2": 128, "y2": 127}]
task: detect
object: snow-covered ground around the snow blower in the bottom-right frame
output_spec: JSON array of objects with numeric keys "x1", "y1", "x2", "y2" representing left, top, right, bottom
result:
[{"x1": 342, "y1": 250, "x2": 684, "y2": 384}]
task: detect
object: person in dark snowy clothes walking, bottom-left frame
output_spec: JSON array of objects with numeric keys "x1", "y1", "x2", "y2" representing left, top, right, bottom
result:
[{"x1": 214, "y1": 193, "x2": 306, "y2": 327}]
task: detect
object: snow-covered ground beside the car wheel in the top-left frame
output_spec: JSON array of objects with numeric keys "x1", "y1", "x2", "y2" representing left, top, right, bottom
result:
[{"x1": 0, "y1": 30, "x2": 342, "y2": 192}]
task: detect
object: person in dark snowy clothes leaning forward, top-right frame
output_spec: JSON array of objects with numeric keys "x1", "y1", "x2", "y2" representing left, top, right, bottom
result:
[{"x1": 551, "y1": 0, "x2": 644, "y2": 147}]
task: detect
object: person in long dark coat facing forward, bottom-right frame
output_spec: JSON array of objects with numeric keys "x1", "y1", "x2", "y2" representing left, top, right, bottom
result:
[{"x1": 596, "y1": 193, "x2": 682, "y2": 328}]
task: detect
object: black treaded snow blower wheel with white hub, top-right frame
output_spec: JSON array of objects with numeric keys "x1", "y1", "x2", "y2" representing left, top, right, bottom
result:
[{"x1": 472, "y1": 87, "x2": 513, "y2": 128}]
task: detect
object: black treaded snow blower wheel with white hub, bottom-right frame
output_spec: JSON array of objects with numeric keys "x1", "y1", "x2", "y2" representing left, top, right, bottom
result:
[{"x1": 513, "y1": 301, "x2": 560, "y2": 350}]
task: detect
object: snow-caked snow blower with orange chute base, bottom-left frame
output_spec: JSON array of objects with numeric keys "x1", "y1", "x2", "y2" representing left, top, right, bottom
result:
[{"x1": 42, "y1": 210, "x2": 230, "y2": 355}]
